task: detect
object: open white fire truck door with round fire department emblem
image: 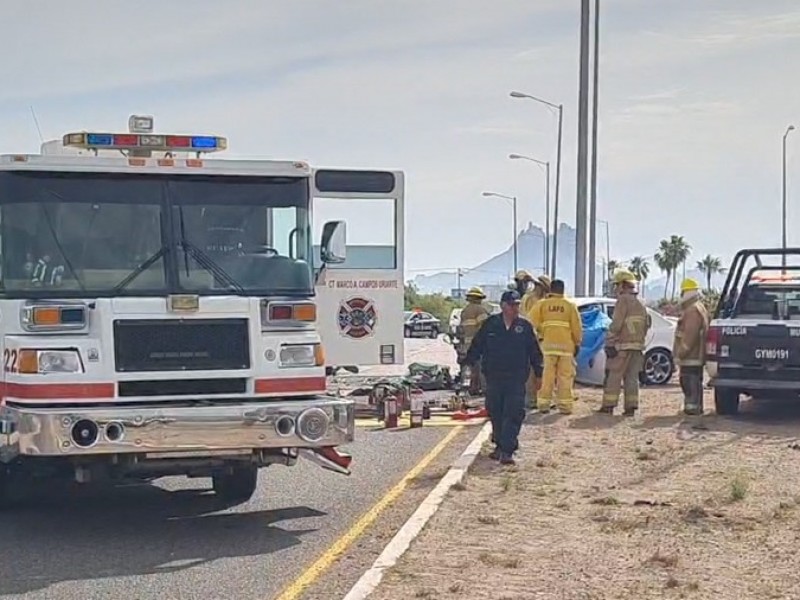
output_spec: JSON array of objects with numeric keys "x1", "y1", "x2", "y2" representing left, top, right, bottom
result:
[{"x1": 312, "y1": 169, "x2": 404, "y2": 367}]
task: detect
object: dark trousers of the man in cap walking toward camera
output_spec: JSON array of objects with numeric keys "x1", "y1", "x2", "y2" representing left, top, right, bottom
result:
[{"x1": 486, "y1": 377, "x2": 525, "y2": 454}]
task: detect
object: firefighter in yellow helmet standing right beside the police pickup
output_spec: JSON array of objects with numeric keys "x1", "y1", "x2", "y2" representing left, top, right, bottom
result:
[{"x1": 672, "y1": 279, "x2": 708, "y2": 415}]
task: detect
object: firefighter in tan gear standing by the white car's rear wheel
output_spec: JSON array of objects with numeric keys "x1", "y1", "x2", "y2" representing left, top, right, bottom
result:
[{"x1": 599, "y1": 269, "x2": 651, "y2": 417}]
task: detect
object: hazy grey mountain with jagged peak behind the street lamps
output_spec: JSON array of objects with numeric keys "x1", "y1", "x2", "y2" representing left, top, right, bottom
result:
[{"x1": 412, "y1": 223, "x2": 725, "y2": 300}]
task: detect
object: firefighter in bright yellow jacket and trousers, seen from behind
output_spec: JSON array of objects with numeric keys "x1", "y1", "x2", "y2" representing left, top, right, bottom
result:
[{"x1": 531, "y1": 279, "x2": 583, "y2": 414}]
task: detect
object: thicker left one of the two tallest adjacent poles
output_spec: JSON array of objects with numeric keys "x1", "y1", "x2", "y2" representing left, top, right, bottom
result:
[{"x1": 575, "y1": 0, "x2": 591, "y2": 296}]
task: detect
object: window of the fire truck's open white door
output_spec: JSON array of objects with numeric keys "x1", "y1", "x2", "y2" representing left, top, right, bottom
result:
[{"x1": 312, "y1": 198, "x2": 397, "y2": 269}]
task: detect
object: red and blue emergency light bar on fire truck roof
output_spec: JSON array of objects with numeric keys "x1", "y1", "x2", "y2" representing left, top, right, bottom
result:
[{"x1": 63, "y1": 132, "x2": 228, "y2": 152}]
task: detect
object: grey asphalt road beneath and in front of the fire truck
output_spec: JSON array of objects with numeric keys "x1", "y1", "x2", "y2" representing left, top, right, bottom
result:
[{"x1": 0, "y1": 340, "x2": 468, "y2": 600}]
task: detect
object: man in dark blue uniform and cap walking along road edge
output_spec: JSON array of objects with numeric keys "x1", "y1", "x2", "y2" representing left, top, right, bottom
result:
[{"x1": 461, "y1": 290, "x2": 543, "y2": 465}]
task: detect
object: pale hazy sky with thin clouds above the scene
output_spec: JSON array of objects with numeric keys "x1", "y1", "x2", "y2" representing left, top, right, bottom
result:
[{"x1": 0, "y1": 0, "x2": 800, "y2": 277}]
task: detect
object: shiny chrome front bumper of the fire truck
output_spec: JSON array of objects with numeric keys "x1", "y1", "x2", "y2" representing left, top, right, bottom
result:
[{"x1": 0, "y1": 397, "x2": 355, "y2": 461}]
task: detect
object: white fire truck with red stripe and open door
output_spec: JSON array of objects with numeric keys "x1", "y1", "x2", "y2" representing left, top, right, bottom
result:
[{"x1": 0, "y1": 116, "x2": 404, "y2": 503}]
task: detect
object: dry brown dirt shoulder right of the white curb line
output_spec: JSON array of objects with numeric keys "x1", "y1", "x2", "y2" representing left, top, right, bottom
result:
[{"x1": 372, "y1": 387, "x2": 800, "y2": 600}]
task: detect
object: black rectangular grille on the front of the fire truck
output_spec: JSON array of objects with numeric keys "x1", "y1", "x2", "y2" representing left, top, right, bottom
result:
[{"x1": 114, "y1": 319, "x2": 250, "y2": 373}]
